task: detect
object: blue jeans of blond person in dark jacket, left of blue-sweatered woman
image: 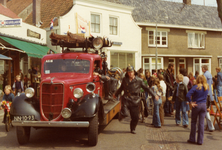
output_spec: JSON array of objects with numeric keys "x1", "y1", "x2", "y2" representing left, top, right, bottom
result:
[{"x1": 175, "y1": 98, "x2": 189, "y2": 125}]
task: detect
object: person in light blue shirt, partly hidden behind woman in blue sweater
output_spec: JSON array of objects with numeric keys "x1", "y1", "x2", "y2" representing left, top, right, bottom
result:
[{"x1": 202, "y1": 65, "x2": 215, "y2": 132}]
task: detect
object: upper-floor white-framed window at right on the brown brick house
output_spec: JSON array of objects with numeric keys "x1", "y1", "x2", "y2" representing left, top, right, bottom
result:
[{"x1": 188, "y1": 32, "x2": 205, "y2": 48}]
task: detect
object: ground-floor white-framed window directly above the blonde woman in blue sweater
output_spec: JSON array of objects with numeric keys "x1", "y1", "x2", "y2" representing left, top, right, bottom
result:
[{"x1": 193, "y1": 58, "x2": 211, "y2": 74}]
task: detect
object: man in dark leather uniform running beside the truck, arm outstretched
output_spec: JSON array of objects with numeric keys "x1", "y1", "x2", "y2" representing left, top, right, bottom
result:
[{"x1": 114, "y1": 66, "x2": 161, "y2": 134}]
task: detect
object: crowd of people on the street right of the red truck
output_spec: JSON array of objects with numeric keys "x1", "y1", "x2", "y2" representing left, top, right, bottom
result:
[{"x1": 116, "y1": 64, "x2": 222, "y2": 145}]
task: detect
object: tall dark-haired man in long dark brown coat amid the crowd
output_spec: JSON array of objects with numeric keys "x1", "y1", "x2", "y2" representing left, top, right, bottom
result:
[{"x1": 164, "y1": 63, "x2": 175, "y2": 116}]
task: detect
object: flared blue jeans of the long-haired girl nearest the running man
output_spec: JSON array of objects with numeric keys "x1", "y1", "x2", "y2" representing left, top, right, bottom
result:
[{"x1": 153, "y1": 99, "x2": 162, "y2": 127}]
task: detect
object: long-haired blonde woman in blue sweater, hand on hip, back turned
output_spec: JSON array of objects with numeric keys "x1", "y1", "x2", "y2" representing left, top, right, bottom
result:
[{"x1": 186, "y1": 75, "x2": 209, "y2": 145}]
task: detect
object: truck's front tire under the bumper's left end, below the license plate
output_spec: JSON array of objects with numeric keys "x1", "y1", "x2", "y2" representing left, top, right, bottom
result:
[{"x1": 16, "y1": 126, "x2": 30, "y2": 145}]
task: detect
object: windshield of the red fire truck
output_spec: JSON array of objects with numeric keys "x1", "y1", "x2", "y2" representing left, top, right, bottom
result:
[{"x1": 44, "y1": 59, "x2": 90, "y2": 74}]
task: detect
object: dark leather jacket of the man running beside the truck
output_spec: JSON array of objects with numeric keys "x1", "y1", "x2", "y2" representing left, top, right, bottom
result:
[{"x1": 115, "y1": 76, "x2": 156, "y2": 103}]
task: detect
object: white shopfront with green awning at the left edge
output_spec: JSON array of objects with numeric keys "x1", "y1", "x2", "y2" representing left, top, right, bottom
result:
[{"x1": 0, "y1": 4, "x2": 50, "y2": 87}]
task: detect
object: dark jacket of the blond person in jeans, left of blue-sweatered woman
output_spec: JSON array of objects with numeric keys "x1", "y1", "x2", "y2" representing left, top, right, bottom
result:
[{"x1": 172, "y1": 82, "x2": 188, "y2": 102}]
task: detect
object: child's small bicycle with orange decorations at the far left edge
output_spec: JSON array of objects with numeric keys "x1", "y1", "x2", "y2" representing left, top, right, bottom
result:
[{"x1": 1, "y1": 101, "x2": 12, "y2": 132}]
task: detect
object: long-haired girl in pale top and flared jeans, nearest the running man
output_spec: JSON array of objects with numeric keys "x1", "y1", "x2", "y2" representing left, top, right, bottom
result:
[{"x1": 152, "y1": 78, "x2": 163, "y2": 128}]
